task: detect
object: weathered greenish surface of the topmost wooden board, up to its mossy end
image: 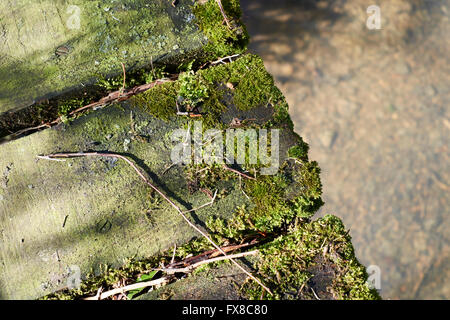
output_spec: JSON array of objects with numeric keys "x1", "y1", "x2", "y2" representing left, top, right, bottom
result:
[{"x1": 0, "y1": 0, "x2": 205, "y2": 114}]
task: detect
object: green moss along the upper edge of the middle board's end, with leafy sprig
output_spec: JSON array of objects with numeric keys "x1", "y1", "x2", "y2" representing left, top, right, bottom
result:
[{"x1": 134, "y1": 54, "x2": 282, "y2": 128}]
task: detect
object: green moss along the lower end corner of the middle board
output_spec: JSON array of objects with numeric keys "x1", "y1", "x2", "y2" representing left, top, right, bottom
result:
[{"x1": 207, "y1": 162, "x2": 323, "y2": 241}]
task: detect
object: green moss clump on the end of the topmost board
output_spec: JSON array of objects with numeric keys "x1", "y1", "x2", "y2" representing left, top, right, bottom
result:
[{"x1": 193, "y1": 0, "x2": 249, "y2": 60}]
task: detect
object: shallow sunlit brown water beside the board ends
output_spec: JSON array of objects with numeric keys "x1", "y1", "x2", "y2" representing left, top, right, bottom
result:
[{"x1": 241, "y1": 0, "x2": 450, "y2": 299}]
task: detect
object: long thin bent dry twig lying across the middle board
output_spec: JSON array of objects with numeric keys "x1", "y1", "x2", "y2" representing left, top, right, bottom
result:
[{"x1": 38, "y1": 152, "x2": 272, "y2": 294}]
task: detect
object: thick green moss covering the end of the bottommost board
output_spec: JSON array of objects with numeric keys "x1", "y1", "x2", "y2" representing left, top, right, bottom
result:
[{"x1": 242, "y1": 215, "x2": 379, "y2": 300}]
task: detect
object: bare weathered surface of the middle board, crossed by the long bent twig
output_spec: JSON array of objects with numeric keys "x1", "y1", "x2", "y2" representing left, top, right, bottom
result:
[{"x1": 0, "y1": 104, "x2": 246, "y2": 299}]
